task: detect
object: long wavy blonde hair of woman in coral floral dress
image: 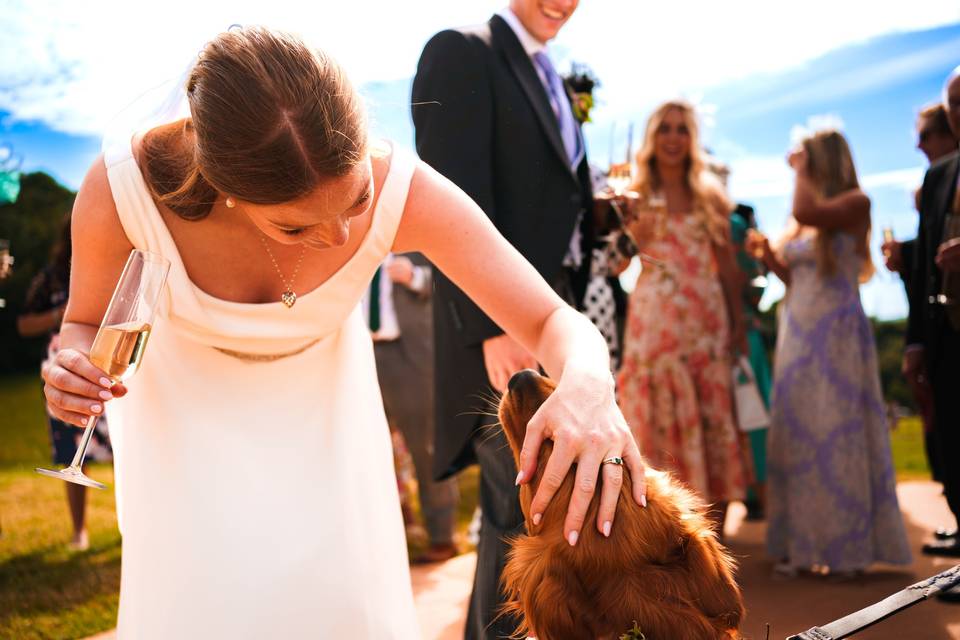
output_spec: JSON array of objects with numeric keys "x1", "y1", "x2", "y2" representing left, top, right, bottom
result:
[{"x1": 632, "y1": 100, "x2": 733, "y2": 245}]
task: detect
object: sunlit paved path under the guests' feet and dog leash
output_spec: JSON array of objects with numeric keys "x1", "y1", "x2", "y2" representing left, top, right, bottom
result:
[{"x1": 84, "y1": 482, "x2": 960, "y2": 640}]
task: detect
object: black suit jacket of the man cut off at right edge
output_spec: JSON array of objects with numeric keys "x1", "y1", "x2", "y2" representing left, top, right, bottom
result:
[{"x1": 907, "y1": 152, "x2": 960, "y2": 360}]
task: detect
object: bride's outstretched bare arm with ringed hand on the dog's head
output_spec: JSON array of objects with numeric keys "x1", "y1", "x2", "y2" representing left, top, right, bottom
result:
[{"x1": 394, "y1": 163, "x2": 645, "y2": 543}]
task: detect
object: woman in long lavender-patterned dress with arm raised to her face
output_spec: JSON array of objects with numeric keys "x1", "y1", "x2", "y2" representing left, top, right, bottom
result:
[{"x1": 750, "y1": 130, "x2": 910, "y2": 575}]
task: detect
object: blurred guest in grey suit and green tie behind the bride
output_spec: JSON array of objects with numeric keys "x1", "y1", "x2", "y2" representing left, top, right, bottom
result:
[{"x1": 364, "y1": 254, "x2": 458, "y2": 564}]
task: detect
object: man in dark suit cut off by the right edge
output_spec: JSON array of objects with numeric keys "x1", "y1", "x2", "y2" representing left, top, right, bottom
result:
[{"x1": 903, "y1": 67, "x2": 960, "y2": 568}]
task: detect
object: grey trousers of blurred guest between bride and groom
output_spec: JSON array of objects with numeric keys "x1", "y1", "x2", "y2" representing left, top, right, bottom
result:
[{"x1": 374, "y1": 338, "x2": 459, "y2": 544}]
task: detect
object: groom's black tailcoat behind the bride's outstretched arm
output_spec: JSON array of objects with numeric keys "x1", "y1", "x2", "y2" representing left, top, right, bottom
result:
[{"x1": 412, "y1": 16, "x2": 593, "y2": 479}]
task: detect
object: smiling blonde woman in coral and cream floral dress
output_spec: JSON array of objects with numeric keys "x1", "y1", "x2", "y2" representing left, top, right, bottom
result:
[{"x1": 618, "y1": 101, "x2": 746, "y2": 532}]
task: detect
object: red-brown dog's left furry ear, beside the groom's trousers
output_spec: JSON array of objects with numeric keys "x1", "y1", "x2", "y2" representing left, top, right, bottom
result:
[{"x1": 502, "y1": 538, "x2": 599, "y2": 640}]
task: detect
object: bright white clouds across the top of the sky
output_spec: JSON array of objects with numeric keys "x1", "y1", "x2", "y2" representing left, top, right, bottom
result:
[{"x1": 0, "y1": 0, "x2": 960, "y2": 134}]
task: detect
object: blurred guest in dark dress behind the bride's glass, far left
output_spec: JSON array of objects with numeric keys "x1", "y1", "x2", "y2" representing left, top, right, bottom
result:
[{"x1": 17, "y1": 213, "x2": 111, "y2": 551}]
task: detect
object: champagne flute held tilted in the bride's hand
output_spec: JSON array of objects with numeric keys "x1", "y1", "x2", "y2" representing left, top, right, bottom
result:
[{"x1": 36, "y1": 249, "x2": 170, "y2": 489}]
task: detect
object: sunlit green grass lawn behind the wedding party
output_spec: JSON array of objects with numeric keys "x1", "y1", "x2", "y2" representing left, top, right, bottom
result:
[{"x1": 0, "y1": 375, "x2": 930, "y2": 640}]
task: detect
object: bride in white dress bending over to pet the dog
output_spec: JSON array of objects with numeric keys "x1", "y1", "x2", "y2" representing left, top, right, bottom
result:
[{"x1": 43, "y1": 28, "x2": 644, "y2": 638}]
